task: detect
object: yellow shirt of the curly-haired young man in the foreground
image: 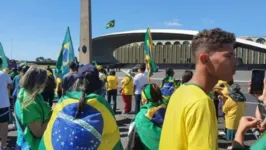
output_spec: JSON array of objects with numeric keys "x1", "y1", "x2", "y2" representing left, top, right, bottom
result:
[{"x1": 160, "y1": 83, "x2": 218, "y2": 150}]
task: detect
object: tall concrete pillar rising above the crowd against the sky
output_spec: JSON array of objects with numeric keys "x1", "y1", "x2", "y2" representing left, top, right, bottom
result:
[{"x1": 79, "y1": 0, "x2": 92, "y2": 64}]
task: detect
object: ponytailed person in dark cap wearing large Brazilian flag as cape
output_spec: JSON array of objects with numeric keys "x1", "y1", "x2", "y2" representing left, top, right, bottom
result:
[{"x1": 39, "y1": 64, "x2": 123, "y2": 150}]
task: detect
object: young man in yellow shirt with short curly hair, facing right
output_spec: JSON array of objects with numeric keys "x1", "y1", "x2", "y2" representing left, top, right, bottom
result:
[{"x1": 160, "y1": 28, "x2": 236, "y2": 150}]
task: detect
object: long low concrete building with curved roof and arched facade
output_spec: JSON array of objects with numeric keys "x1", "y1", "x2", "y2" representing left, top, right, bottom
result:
[{"x1": 92, "y1": 30, "x2": 266, "y2": 64}]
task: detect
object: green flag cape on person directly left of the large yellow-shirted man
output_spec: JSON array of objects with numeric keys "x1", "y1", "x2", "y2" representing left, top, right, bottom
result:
[{"x1": 135, "y1": 102, "x2": 166, "y2": 149}]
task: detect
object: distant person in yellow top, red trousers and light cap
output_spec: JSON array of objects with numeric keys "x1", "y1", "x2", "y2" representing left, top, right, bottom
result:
[{"x1": 120, "y1": 70, "x2": 134, "y2": 114}]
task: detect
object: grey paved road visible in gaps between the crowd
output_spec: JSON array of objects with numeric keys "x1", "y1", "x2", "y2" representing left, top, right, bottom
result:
[{"x1": 3, "y1": 70, "x2": 257, "y2": 150}]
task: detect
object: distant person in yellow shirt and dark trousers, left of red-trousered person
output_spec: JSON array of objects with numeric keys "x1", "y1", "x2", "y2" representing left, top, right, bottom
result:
[{"x1": 106, "y1": 71, "x2": 118, "y2": 113}]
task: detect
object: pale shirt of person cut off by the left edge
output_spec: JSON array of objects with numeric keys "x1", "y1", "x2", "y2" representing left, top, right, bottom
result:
[{"x1": 0, "y1": 71, "x2": 12, "y2": 108}]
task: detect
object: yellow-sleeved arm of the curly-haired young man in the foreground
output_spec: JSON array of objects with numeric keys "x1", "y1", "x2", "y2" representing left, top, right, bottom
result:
[{"x1": 186, "y1": 98, "x2": 218, "y2": 150}]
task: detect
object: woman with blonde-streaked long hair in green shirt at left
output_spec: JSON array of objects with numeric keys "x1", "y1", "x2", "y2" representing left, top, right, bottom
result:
[{"x1": 15, "y1": 67, "x2": 51, "y2": 150}]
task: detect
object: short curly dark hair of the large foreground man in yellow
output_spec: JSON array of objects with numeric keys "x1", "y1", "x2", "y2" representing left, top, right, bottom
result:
[{"x1": 191, "y1": 28, "x2": 236, "y2": 57}]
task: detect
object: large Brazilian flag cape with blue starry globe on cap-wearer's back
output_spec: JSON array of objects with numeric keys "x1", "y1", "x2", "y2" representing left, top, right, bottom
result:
[{"x1": 39, "y1": 92, "x2": 123, "y2": 150}]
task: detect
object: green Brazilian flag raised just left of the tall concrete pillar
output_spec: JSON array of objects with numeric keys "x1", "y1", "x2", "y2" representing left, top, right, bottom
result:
[{"x1": 55, "y1": 27, "x2": 75, "y2": 78}]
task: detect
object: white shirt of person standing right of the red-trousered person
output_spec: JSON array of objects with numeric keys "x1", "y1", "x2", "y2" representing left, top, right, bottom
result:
[{"x1": 134, "y1": 72, "x2": 148, "y2": 95}]
